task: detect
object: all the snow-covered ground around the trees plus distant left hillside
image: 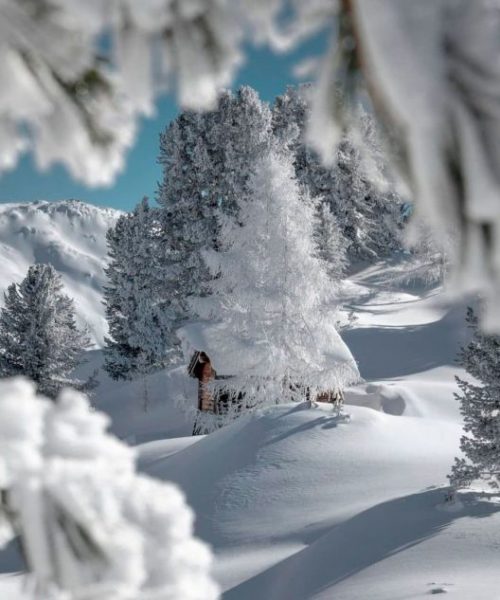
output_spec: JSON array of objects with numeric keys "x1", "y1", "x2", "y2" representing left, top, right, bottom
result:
[{"x1": 0, "y1": 203, "x2": 500, "y2": 600}]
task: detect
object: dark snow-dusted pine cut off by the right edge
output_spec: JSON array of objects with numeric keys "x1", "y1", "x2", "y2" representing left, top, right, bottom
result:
[{"x1": 449, "y1": 307, "x2": 500, "y2": 489}]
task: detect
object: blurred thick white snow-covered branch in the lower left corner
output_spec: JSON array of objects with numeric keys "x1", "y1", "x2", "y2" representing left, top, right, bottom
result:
[{"x1": 0, "y1": 379, "x2": 218, "y2": 600}]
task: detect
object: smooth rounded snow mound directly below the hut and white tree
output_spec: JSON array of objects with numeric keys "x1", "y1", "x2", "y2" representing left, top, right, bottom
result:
[{"x1": 145, "y1": 404, "x2": 460, "y2": 544}]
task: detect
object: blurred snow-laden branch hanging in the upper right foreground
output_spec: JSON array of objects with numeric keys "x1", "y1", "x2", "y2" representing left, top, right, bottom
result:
[{"x1": 343, "y1": 0, "x2": 500, "y2": 331}]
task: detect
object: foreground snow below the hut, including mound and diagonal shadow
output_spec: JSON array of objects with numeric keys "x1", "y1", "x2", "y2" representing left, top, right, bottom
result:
[{"x1": 144, "y1": 396, "x2": 500, "y2": 600}]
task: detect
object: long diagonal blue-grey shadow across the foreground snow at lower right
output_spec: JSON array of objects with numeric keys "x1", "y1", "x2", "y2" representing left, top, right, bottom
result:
[{"x1": 224, "y1": 488, "x2": 500, "y2": 600}]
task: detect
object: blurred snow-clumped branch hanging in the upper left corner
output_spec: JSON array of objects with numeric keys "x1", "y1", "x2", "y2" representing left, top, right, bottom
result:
[{"x1": 0, "y1": 0, "x2": 241, "y2": 185}]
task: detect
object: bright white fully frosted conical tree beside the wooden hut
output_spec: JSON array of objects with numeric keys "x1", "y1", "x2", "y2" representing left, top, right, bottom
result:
[{"x1": 193, "y1": 145, "x2": 358, "y2": 426}]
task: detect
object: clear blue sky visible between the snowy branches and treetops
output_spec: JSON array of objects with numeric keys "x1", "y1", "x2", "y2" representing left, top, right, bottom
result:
[{"x1": 0, "y1": 36, "x2": 325, "y2": 210}]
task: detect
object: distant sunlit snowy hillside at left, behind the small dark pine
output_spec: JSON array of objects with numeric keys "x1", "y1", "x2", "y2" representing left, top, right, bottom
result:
[{"x1": 0, "y1": 200, "x2": 120, "y2": 345}]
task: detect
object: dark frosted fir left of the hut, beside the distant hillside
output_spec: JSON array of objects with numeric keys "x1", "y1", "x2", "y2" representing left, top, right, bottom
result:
[{"x1": 104, "y1": 198, "x2": 178, "y2": 379}]
